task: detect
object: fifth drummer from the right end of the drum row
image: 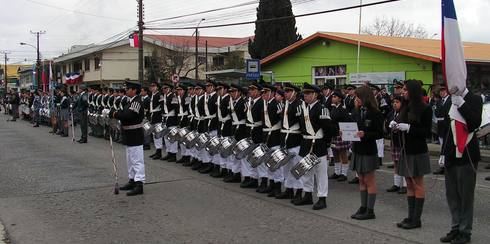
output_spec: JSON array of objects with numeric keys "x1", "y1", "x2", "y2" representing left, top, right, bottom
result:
[{"x1": 223, "y1": 84, "x2": 248, "y2": 183}]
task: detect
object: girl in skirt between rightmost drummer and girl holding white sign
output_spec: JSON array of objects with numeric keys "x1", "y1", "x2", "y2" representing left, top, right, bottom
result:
[{"x1": 329, "y1": 90, "x2": 351, "y2": 182}]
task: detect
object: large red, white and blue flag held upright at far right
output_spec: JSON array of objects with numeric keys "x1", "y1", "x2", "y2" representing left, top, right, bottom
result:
[{"x1": 441, "y1": 0, "x2": 473, "y2": 158}]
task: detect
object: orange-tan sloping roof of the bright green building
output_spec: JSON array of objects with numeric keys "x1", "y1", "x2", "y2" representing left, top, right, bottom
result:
[{"x1": 261, "y1": 32, "x2": 490, "y2": 64}]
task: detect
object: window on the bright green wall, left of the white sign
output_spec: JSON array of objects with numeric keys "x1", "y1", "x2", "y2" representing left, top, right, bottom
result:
[{"x1": 313, "y1": 65, "x2": 347, "y2": 86}]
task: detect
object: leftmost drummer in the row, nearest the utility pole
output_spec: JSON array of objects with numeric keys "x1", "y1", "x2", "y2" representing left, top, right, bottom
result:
[{"x1": 149, "y1": 81, "x2": 163, "y2": 160}]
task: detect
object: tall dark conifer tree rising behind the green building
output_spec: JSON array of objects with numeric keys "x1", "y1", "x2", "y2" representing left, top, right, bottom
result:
[{"x1": 248, "y1": 0, "x2": 302, "y2": 59}]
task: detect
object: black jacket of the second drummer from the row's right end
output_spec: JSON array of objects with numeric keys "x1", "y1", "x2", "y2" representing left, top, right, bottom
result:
[{"x1": 281, "y1": 99, "x2": 303, "y2": 149}]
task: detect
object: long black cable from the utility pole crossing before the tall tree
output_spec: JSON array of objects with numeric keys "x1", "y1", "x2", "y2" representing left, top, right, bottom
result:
[{"x1": 146, "y1": 0, "x2": 402, "y2": 30}]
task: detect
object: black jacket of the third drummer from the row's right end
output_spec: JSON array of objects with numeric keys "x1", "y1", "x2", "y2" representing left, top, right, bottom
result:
[{"x1": 262, "y1": 99, "x2": 284, "y2": 148}]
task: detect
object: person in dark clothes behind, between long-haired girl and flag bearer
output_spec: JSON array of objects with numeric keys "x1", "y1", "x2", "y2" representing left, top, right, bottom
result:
[{"x1": 434, "y1": 86, "x2": 452, "y2": 175}]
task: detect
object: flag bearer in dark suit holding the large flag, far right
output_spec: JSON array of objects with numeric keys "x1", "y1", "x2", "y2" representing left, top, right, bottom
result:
[{"x1": 441, "y1": 86, "x2": 483, "y2": 243}]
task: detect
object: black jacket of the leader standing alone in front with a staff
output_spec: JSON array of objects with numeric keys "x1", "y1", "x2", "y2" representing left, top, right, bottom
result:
[{"x1": 113, "y1": 96, "x2": 145, "y2": 147}]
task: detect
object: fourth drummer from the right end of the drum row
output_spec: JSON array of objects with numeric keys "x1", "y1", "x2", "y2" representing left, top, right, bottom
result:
[{"x1": 240, "y1": 82, "x2": 264, "y2": 188}]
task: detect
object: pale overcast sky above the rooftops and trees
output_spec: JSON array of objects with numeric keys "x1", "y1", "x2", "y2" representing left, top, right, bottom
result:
[{"x1": 0, "y1": 0, "x2": 490, "y2": 63}]
